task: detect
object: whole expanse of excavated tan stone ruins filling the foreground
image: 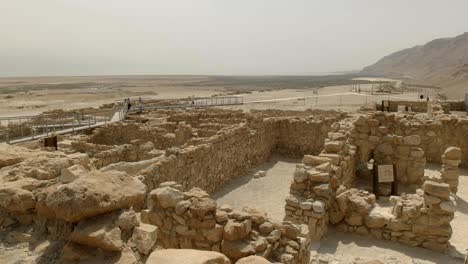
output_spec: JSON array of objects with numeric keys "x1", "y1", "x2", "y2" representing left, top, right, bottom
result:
[{"x1": 0, "y1": 109, "x2": 468, "y2": 264}]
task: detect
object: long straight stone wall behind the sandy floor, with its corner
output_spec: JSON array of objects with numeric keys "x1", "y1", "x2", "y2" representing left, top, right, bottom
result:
[{"x1": 132, "y1": 110, "x2": 342, "y2": 192}]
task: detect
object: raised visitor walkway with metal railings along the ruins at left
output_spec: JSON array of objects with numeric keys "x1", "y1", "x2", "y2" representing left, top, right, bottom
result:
[{"x1": 0, "y1": 96, "x2": 243, "y2": 144}]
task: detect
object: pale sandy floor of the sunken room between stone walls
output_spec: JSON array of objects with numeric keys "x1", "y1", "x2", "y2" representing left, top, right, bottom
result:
[{"x1": 212, "y1": 156, "x2": 301, "y2": 222}]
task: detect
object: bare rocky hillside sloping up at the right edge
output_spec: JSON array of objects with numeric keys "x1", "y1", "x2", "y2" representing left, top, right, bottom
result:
[{"x1": 361, "y1": 32, "x2": 468, "y2": 97}]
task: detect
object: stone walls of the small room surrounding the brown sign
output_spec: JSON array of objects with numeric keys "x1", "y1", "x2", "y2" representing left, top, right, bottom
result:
[{"x1": 285, "y1": 113, "x2": 461, "y2": 251}]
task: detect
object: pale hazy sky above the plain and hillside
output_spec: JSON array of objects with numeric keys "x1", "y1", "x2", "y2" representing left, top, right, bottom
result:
[{"x1": 0, "y1": 0, "x2": 468, "y2": 76}]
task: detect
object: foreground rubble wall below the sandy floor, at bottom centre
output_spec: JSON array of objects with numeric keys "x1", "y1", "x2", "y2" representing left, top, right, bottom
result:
[{"x1": 141, "y1": 182, "x2": 310, "y2": 264}]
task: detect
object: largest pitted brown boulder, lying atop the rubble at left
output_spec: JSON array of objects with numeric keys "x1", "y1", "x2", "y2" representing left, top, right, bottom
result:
[{"x1": 37, "y1": 171, "x2": 146, "y2": 222}]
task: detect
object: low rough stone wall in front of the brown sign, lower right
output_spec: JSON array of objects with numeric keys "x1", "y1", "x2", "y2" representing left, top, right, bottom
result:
[{"x1": 336, "y1": 181, "x2": 455, "y2": 251}]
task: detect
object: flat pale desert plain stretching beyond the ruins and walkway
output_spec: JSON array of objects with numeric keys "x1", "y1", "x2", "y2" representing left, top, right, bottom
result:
[{"x1": 0, "y1": 76, "x2": 432, "y2": 117}]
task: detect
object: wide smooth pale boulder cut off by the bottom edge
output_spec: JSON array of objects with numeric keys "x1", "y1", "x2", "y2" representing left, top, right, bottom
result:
[{"x1": 146, "y1": 249, "x2": 231, "y2": 264}]
